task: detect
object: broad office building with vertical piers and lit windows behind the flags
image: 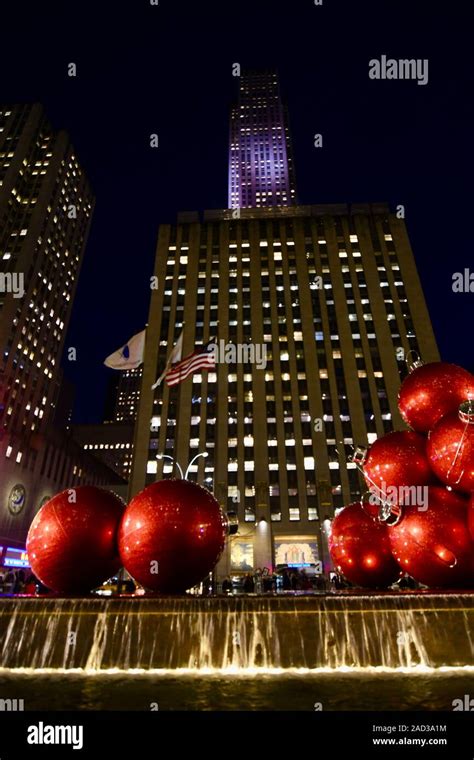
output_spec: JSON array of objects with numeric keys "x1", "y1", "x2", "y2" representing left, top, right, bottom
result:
[{"x1": 131, "y1": 204, "x2": 439, "y2": 575}]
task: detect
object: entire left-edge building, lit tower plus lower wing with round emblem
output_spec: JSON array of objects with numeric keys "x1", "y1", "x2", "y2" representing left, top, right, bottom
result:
[{"x1": 0, "y1": 105, "x2": 124, "y2": 546}]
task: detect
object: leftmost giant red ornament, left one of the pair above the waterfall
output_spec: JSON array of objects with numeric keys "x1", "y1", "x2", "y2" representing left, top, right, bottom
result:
[{"x1": 26, "y1": 486, "x2": 125, "y2": 594}]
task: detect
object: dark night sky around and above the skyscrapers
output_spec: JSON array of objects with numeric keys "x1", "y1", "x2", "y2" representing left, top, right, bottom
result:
[{"x1": 0, "y1": 0, "x2": 474, "y2": 422}]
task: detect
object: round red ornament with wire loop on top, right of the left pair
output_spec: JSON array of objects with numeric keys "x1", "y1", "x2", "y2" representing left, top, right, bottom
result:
[{"x1": 119, "y1": 479, "x2": 227, "y2": 594}]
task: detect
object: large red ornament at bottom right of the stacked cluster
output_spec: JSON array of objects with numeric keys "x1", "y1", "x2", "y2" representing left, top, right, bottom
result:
[{"x1": 388, "y1": 486, "x2": 474, "y2": 588}]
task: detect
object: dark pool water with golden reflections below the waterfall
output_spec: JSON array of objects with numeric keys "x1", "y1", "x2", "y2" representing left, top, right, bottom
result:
[{"x1": 0, "y1": 668, "x2": 474, "y2": 711}]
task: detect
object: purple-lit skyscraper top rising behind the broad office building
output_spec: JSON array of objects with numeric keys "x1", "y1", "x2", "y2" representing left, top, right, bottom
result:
[{"x1": 229, "y1": 72, "x2": 296, "y2": 208}]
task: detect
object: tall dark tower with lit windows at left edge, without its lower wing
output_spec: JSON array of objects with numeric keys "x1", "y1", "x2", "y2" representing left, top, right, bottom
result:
[{"x1": 0, "y1": 104, "x2": 93, "y2": 440}]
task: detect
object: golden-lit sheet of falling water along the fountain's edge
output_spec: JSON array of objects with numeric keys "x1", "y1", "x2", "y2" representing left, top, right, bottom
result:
[{"x1": 0, "y1": 593, "x2": 474, "y2": 672}]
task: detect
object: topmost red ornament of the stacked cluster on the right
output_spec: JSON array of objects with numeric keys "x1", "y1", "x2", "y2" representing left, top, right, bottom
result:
[{"x1": 398, "y1": 362, "x2": 474, "y2": 433}]
